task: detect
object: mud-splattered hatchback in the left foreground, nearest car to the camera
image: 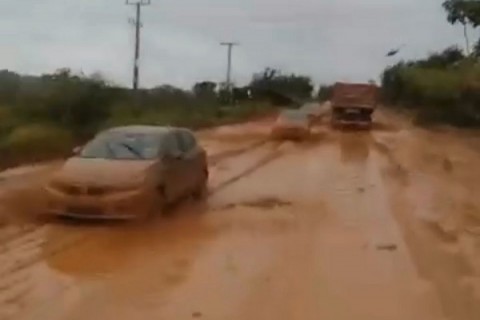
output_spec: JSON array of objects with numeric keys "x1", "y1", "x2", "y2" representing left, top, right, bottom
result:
[{"x1": 44, "y1": 126, "x2": 208, "y2": 219}]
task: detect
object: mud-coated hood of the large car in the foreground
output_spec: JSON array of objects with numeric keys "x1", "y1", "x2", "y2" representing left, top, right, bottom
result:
[{"x1": 54, "y1": 158, "x2": 155, "y2": 186}]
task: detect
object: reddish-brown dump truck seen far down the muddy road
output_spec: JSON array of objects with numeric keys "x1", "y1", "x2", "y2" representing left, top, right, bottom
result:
[{"x1": 331, "y1": 82, "x2": 378, "y2": 129}]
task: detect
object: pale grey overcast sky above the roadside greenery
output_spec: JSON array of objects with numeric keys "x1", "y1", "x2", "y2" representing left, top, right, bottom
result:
[{"x1": 0, "y1": 0, "x2": 473, "y2": 88}]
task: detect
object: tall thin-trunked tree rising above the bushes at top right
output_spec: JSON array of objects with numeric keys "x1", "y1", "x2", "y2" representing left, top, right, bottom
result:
[{"x1": 443, "y1": 0, "x2": 480, "y2": 55}]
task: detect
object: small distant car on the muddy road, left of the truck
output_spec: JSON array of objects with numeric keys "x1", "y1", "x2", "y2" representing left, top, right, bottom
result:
[{"x1": 271, "y1": 109, "x2": 311, "y2": 140}]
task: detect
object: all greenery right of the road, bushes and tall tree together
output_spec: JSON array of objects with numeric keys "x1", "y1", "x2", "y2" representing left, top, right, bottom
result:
[{"x1": 382, "y1": 0, "x2": 480, "y2": 127}]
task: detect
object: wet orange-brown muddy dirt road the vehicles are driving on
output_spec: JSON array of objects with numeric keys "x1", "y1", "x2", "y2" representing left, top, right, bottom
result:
[{"x1": 0, "y1": 110, "x2": 480, "y2": 320}]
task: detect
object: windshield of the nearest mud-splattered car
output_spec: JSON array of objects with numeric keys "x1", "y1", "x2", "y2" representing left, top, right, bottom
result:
[{"x1": 79, "y1": 133, "x2": 165, "y2": 160}]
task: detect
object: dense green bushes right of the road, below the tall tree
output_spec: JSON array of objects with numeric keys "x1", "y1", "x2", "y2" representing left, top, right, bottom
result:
[{"x1": 382, "y1": 49, "x2": 480, "y2": 126}]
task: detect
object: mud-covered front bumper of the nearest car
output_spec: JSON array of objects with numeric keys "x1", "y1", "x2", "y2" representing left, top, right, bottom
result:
[{"x1": 45, "y1": 189, "x2": 152, "y2": 220}]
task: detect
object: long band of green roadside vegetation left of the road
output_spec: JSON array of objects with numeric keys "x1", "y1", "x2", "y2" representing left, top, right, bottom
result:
[{"x1": 0, "y1": 68, "x2": 313, "y2": 168}]
